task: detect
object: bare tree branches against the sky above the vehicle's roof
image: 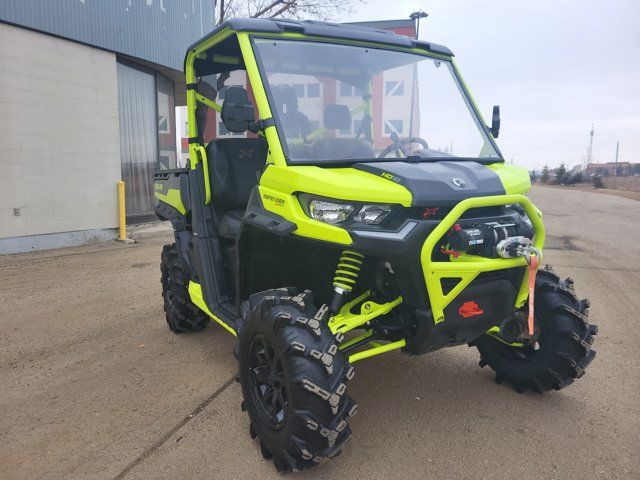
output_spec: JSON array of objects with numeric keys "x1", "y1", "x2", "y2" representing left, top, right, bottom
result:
[{"x1": 217, "y1": 0, "x2": 366, "y2": 25}]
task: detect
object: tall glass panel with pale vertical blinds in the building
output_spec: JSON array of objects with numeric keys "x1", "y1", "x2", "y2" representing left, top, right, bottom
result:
[{"x1": 118, "y1": 62, "x2": 158, "y2": 223}]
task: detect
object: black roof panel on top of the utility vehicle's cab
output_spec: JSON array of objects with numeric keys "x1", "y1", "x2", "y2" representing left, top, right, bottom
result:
[{"x1": 189, "y1": 18, "x2": 453, "y2": 56}]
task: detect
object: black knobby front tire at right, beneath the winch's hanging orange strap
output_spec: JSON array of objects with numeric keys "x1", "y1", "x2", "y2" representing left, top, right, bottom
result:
[{"x1": 474, "y1": 267, "x2": 598, "y2": 393}]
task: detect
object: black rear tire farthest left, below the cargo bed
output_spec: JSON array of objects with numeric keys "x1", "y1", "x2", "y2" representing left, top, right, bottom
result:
[{"x1": 160, "y1": 243, "x2": 209, "y2": 333}]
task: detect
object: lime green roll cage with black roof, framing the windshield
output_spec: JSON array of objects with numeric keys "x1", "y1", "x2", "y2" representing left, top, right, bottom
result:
[{"x1": 184, "y1": 19, "x2": 504, "y2": 172}]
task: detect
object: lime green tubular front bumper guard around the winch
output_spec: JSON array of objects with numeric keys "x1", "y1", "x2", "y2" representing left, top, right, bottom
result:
[{"x1": 420, "y1": 195, "x2": 545, "y2": 323}]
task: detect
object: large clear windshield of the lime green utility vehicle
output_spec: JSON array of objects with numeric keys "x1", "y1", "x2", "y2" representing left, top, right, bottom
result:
[{"x1": 255, "y1": 39, "x2": 500, "y2": 164}]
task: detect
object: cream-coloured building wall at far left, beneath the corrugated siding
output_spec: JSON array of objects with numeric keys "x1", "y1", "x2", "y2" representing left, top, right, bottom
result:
[{"x1": 0, "y1": 23, "x2": 121, "y2": 253}]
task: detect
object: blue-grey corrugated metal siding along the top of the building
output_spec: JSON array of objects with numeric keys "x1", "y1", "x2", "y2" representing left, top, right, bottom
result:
[{"x1": 0, "y1": 0, "x2": 214, "y2": 70}]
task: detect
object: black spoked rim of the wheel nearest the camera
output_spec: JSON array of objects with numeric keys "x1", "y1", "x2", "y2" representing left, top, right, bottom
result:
[{"x1": 249, "y1": 335, "x2": 288, "y2": 430}]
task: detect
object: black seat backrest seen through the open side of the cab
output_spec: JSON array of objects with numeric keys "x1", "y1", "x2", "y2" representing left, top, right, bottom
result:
[{"x1": 207, "y1": 138, "x2": 267, "y2": 211}]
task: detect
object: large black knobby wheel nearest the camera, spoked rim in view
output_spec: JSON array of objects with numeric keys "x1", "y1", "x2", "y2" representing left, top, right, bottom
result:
[{"x1": 238, "y1": 289, "x2": 356, "y2": 472}]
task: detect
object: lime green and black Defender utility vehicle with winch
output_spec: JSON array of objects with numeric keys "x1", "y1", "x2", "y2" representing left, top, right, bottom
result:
[{"x1": 155, "y1": 19, "x2": 596, "y2": 471}]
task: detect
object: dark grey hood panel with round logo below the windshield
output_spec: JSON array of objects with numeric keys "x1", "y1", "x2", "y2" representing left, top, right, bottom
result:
[{"x1": 353, "y1": 161, "x2": 506, "y2": 207}]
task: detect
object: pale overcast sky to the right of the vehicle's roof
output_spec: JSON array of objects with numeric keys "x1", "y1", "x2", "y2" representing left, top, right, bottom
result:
[{"x1": 350, "y1": 0, "x2": 640, "y2": 168}]
